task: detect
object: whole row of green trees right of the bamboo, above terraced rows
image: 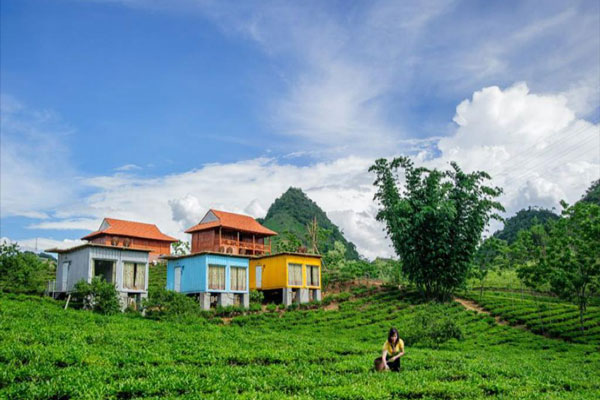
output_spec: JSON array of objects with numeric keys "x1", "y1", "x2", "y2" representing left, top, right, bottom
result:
[{"x1": 473, "y1": 201, "x2": 600, "y2": 326}]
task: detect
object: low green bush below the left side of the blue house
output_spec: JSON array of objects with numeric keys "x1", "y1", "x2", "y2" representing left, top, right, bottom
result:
[{"x1": 143, "y1": 288, "x2": 201, "y2": 319}]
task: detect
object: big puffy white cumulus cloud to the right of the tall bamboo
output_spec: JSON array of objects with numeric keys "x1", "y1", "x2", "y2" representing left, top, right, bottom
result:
[{"x1": 428, "y1": 83, "x2": 600, "y2": 219}]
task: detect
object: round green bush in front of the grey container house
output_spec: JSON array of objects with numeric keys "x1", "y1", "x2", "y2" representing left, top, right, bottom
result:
[{"x1": 73, "y1": 276, "x2": 121, "y2": 314}]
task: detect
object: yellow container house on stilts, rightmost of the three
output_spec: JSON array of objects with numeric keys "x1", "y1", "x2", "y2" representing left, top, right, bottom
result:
[{"x1": 249, "y1": 253, "x2": 321, "y2": 306}]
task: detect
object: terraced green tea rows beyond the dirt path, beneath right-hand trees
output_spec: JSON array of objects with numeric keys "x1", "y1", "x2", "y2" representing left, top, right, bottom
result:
[{"x1": 462, "y1": 290, "x2": 600, "y2": 345}]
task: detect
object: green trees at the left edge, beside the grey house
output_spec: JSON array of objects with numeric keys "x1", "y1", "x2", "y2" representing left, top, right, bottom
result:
[{"x1": 0, "y1": 242, "x2": 55, "y2": 294}]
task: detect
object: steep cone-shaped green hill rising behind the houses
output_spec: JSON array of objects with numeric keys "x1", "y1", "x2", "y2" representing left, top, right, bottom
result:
[{"x1": 257, "y1": 187, "x2": 358, "y2": 260}]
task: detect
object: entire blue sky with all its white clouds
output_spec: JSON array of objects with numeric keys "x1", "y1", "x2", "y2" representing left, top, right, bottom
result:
[{"x1": 0, "y1": 0, "x2": 600, "y2": 256}]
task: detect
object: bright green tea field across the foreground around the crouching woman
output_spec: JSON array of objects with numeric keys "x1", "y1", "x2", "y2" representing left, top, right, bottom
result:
[{"x1": 0, "y1": 291, "x2": 600, "y2": 399}]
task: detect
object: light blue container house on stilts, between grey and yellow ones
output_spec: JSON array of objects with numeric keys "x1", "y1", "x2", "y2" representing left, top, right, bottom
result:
[{"x1": 163, "y1": 252, "x2": 250, "y2": 310}]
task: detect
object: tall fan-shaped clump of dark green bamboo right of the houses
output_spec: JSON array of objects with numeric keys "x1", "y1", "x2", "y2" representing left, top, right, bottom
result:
[{"x1": 369, "y1": 157, "x2": 504, "y2": 299}]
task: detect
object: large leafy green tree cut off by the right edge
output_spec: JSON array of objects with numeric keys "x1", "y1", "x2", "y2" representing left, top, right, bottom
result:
[{"x1": 520, "y1": 201, "x2": 600, "y2": 330}]
